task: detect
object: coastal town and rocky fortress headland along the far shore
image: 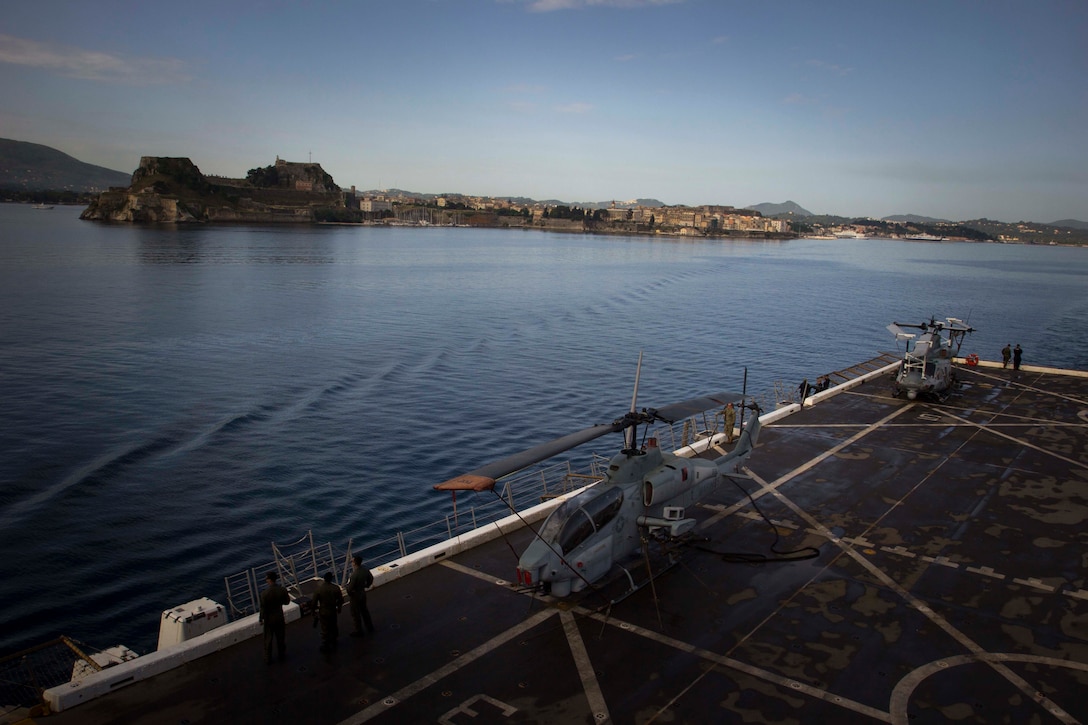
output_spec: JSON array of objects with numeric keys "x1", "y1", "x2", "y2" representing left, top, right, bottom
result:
[{"x1": 30, "y1": 148, "x2": 1088, "y2": 246}]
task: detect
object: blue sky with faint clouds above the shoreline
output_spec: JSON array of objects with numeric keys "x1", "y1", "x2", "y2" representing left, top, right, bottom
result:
[{"x1": 0, "y1": 0, "x2": 1088, "y2": 222}]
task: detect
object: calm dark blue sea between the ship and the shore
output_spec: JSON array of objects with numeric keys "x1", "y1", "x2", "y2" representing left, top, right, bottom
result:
[{"x1": 6, "y1": 205, "x2": 1088, "y2": 655}]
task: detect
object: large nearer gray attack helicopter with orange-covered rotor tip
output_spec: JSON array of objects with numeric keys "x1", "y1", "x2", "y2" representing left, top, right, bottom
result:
[{"x1": 434, "y1": 357, "x2": 759, "y2": 597}]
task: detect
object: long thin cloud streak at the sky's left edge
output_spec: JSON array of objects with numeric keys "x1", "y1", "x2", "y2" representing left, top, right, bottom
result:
[{"x1": 0, "y1": 34, "x2": 189, "y2": 85}]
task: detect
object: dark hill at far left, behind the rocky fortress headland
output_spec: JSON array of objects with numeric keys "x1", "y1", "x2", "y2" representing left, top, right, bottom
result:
[{"x1": 0, "y1": 138, "x2": 132, "y2": 192}]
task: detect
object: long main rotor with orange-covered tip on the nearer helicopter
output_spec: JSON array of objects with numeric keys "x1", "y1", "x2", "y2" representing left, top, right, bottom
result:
[{"x1": 434, "y1": 392, "x2": 741, "y2": 491}]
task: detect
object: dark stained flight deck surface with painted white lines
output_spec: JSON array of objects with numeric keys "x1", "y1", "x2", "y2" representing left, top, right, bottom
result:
[{"x1": 41, "y1": 366, "x2": 1088, "y2": 724}]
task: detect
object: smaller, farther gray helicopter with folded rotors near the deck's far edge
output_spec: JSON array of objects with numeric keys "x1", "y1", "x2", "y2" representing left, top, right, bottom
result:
[{"x1": 888, "y1": 317, "x2": 978, "y2": 401}]
